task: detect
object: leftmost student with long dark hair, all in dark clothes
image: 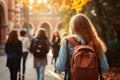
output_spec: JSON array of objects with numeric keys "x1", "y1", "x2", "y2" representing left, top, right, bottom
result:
[{"x1": 5, "y1": 30, "x2": 22, "y2": 80}]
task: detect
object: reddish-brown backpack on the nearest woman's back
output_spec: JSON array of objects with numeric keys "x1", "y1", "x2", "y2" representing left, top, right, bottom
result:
[{"x1": 67, "y1": 38, "x2": 99, "y2": 80}]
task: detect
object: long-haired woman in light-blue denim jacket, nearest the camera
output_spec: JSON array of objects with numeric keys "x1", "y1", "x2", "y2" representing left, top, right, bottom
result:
[{"x1": 56, "y1": 14, "x2": 109, "y2": 80}]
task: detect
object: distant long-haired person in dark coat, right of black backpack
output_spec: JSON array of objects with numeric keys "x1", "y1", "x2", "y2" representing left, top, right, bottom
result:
[{"x1": 51, "y1": 30, "x2": 61, "y2": 73}]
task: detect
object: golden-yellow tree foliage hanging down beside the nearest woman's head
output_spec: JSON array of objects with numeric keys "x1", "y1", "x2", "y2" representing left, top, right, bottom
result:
[{"x1": 50, "y1": 0, "x2": 90, "y2": 32}]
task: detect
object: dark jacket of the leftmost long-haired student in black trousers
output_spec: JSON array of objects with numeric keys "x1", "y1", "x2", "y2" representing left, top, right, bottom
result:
[{"x1": 5, "y1": 41, "x2": 22, "y2": 68}]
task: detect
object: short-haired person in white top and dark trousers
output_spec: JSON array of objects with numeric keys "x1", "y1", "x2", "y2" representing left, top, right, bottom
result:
[{"x1": 19, "y1": 30, "x2": 30, "y2": 80}]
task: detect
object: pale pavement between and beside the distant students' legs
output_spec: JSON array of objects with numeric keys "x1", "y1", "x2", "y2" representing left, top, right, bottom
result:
[{"x1": 0, "y1": 50, "x2": 64, "y2": 80}]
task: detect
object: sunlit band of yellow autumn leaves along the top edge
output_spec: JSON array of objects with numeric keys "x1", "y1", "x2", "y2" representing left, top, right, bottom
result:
[{"x1": 20, "y1": 0, "x2": 90, "y2": 13}]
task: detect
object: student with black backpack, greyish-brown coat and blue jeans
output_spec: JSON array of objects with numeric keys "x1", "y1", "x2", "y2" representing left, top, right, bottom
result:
[{"x1": 30, "y1": 28, "x2": 50, "y2": 80}]
